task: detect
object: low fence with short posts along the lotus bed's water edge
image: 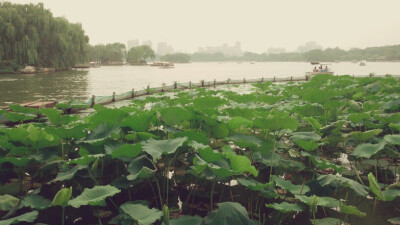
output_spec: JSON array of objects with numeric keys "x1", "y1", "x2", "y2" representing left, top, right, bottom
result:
[{"x1": 86, "y1": 74, "x2": 400, "y2": 107}]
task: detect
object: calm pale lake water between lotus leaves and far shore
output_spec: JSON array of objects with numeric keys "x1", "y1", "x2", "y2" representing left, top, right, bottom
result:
[{"x1": 0, "y1": 62, "x2": 400, "y2": 105}]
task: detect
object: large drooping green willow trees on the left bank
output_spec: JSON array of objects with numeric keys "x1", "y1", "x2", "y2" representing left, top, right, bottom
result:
[{"x1": 0, "y1": 2, "x2": 89, "y2": 71}]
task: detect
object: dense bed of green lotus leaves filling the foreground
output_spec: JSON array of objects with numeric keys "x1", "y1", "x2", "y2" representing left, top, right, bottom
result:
[{"x1": 0, "y1": 75, "x2": 400, "y2": 225}]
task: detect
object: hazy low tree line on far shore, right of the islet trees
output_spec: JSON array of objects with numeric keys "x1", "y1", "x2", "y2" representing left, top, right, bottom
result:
[{"x1": 191, "y1": 45, "x2": 400, "y2": 62}]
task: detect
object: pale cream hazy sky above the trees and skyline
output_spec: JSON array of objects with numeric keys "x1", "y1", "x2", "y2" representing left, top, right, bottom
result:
[{"x1": 7, "y1": 0, "x2": 400, "y2": 53}]
